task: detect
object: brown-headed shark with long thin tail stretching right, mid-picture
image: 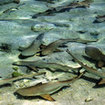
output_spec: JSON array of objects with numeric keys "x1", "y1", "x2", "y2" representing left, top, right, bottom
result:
[{"x1": 41, "y1": 38, "x2": 97, "y2": 55}]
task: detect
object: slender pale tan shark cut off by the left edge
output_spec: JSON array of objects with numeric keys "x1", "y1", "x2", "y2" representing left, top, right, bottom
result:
[{"x1": 0, "y1": 72, "x2": 45, "y2": 85}]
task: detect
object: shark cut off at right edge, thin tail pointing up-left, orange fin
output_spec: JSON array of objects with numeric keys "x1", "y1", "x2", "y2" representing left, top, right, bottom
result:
[{"x1": 67, "y1": 50, "x2": 105, "y2": 85}]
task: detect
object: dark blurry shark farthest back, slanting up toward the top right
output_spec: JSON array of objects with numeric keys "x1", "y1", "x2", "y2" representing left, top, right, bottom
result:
[{"x1": 32, "y1": 0, "x2": 93, "y2": 18}]
